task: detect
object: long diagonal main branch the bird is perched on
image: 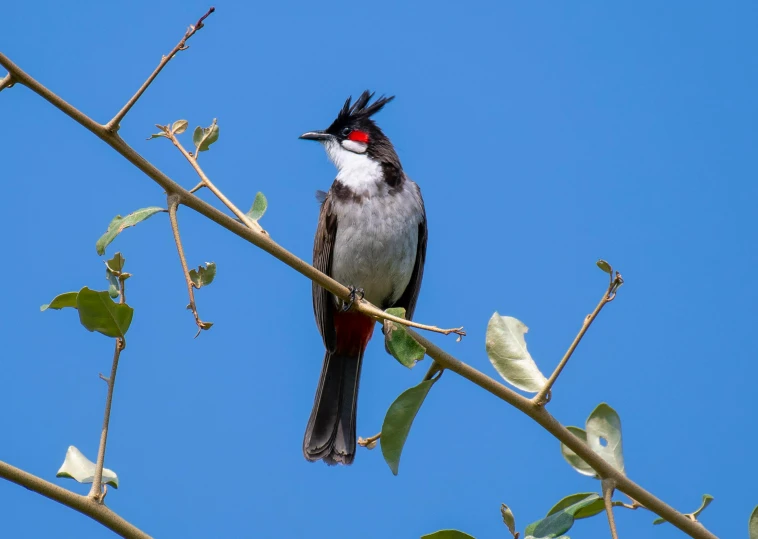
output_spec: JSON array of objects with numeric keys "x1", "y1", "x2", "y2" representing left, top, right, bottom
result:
[{"x1": 0, "y1": 43, "x2": 717, "y2": 539}]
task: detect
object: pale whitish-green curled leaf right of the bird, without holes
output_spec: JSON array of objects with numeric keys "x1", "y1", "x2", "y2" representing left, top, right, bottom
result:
[{"x1": 485, "y1": 312, "x2": 547, "y2": 393}]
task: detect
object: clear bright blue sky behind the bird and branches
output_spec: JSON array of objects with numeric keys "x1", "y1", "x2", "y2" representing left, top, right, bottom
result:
[{"x1": 0, "y1": 0, "x2": 758, "y2": 539}]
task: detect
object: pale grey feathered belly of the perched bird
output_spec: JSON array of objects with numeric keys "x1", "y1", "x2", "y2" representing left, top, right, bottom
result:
[{"x1": 332, "y1": 200, "x2": 418, "y2": 308}]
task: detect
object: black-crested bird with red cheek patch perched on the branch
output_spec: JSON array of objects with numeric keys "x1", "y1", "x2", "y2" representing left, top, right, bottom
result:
[{"x1": 300, "y1": 90, "x2": 427, "y2": 465}]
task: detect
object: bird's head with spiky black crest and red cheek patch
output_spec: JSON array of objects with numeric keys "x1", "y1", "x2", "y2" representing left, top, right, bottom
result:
[{"x1": 300, "y1": 90, "x2": 399, "y2": 168}]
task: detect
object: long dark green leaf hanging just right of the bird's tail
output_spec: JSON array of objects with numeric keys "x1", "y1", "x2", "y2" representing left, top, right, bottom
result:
[{"x1": 380, "y1": 380, "x2": 434, "y2": 475}]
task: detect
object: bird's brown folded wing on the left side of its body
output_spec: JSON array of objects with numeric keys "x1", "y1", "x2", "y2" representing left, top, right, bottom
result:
[{"x1": 313, "y1": 194, "x2": 337, "y2": 351}]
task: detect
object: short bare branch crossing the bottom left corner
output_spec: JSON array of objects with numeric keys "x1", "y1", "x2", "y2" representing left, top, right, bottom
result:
[{"x1": 0, "y1": 461, "x2": 152, "y2": 539}]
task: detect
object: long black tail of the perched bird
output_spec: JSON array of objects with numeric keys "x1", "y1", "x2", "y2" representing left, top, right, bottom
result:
[{"x1": 303, "y1": 351, "x2": 363, "y2": 464}]
